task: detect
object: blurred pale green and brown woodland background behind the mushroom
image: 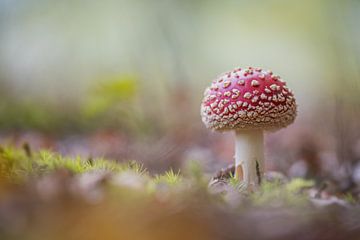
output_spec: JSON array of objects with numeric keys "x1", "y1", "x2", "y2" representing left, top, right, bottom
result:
[{"x1": 0, "y1": 0, "x2": 360, "y2": 189}]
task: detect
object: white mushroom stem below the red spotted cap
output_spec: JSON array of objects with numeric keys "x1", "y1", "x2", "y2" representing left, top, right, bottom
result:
[{"x1": 235, "y1": 130, "x2": 264, "y2": 188}]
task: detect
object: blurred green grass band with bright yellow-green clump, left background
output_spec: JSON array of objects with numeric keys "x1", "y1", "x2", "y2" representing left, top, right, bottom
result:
[{"x1": 0, "y1": 75, "x2": 147, "y2": 134}]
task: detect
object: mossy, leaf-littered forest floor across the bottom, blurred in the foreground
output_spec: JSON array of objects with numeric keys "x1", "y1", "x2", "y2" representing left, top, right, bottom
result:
[{"x1": 0, "y1": 146, "x2": 360, "y2": 240}]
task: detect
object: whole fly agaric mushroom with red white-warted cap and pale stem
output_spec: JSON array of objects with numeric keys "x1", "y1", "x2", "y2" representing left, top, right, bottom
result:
[{"x1": 201, "y1": 67, "x2": 296, "y2": 188}]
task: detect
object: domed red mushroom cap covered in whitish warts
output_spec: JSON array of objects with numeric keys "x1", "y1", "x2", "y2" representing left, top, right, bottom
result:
[{"x1": 201, "y1": 67, "x2": 296, "y2": 131}]
